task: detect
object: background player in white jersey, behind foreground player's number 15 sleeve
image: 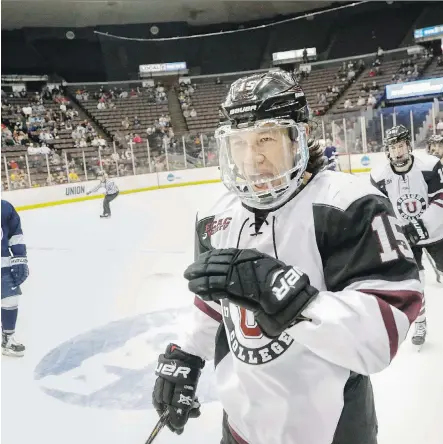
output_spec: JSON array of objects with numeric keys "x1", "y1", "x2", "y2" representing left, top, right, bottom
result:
[{"x1": 371, "y1": 125, "x2": 443, "y2": 345}]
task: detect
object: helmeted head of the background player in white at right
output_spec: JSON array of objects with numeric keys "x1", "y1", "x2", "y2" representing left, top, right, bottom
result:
[{"x1": 384, "y1": 125, "x2": 412, "y2": 171}]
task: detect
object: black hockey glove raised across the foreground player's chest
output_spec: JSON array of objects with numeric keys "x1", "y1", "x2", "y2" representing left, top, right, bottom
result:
[{"x1": 184, "y1": 248, "x2": 318, "y2": 337}]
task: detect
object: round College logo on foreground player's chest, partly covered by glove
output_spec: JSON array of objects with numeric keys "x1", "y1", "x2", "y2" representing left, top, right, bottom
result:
[{"x1": 222, "y1": 299, "x2": 294, "y2": 365}]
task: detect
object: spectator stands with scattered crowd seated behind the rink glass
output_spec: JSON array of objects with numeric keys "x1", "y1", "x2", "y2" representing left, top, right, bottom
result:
[{"x1": 1, "y1": 44, "x2": 443, "y2": 189}]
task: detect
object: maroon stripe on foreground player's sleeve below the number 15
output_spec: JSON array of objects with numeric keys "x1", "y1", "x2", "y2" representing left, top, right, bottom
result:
[{"x1": 358, "y1": 290, "x2": 422, "y2": 360}]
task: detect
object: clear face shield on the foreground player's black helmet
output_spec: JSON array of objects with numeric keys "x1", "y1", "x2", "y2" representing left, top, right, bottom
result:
[{"x1": 215, "y1": 119, "x2": 309, "y2": 207}]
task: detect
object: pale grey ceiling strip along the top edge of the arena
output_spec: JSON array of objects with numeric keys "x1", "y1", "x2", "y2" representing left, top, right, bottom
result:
[{"x1": 1, "y1": 0, "x2": 332, "y2": 29}]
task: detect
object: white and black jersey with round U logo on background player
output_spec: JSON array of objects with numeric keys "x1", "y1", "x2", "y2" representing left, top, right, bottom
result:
[{"x1": 371, "y1": 155, "x2": 443, "y2": 246}]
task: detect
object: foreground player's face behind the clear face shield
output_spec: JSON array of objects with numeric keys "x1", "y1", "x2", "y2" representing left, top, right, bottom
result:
[{"x1": 229, "y1": 125, "x2": 297, "y2": 191}]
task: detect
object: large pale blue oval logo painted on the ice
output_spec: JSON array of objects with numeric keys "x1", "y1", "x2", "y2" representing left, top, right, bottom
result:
[{"x1": 34, "y1": 307, "x2": 215, "y2": 410}]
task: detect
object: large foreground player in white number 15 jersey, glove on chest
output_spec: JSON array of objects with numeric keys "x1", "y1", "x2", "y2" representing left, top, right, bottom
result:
[{"x1": 153, "y1": 70, "x2": 421, "y2": 444}]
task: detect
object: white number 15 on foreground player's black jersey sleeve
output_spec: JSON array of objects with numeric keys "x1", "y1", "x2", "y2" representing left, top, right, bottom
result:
[{"x1": 372, "y1": 215, "x2": 414, "y2": 262}]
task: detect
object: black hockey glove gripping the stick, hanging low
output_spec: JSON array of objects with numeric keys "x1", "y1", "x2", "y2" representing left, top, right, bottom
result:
[{"x1": 152, "y1": 344, "x2": 205, "y2": 435}]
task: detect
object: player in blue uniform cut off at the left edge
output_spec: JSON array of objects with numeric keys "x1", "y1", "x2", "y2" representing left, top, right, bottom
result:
[{"x1": 2, "y1": 199, "x2": 29, "y2": 356}]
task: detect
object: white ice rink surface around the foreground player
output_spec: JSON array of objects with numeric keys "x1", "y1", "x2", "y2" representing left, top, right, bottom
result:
[{"x1": 1, "y1": 180, "x2": 443, "y2": 444}]
